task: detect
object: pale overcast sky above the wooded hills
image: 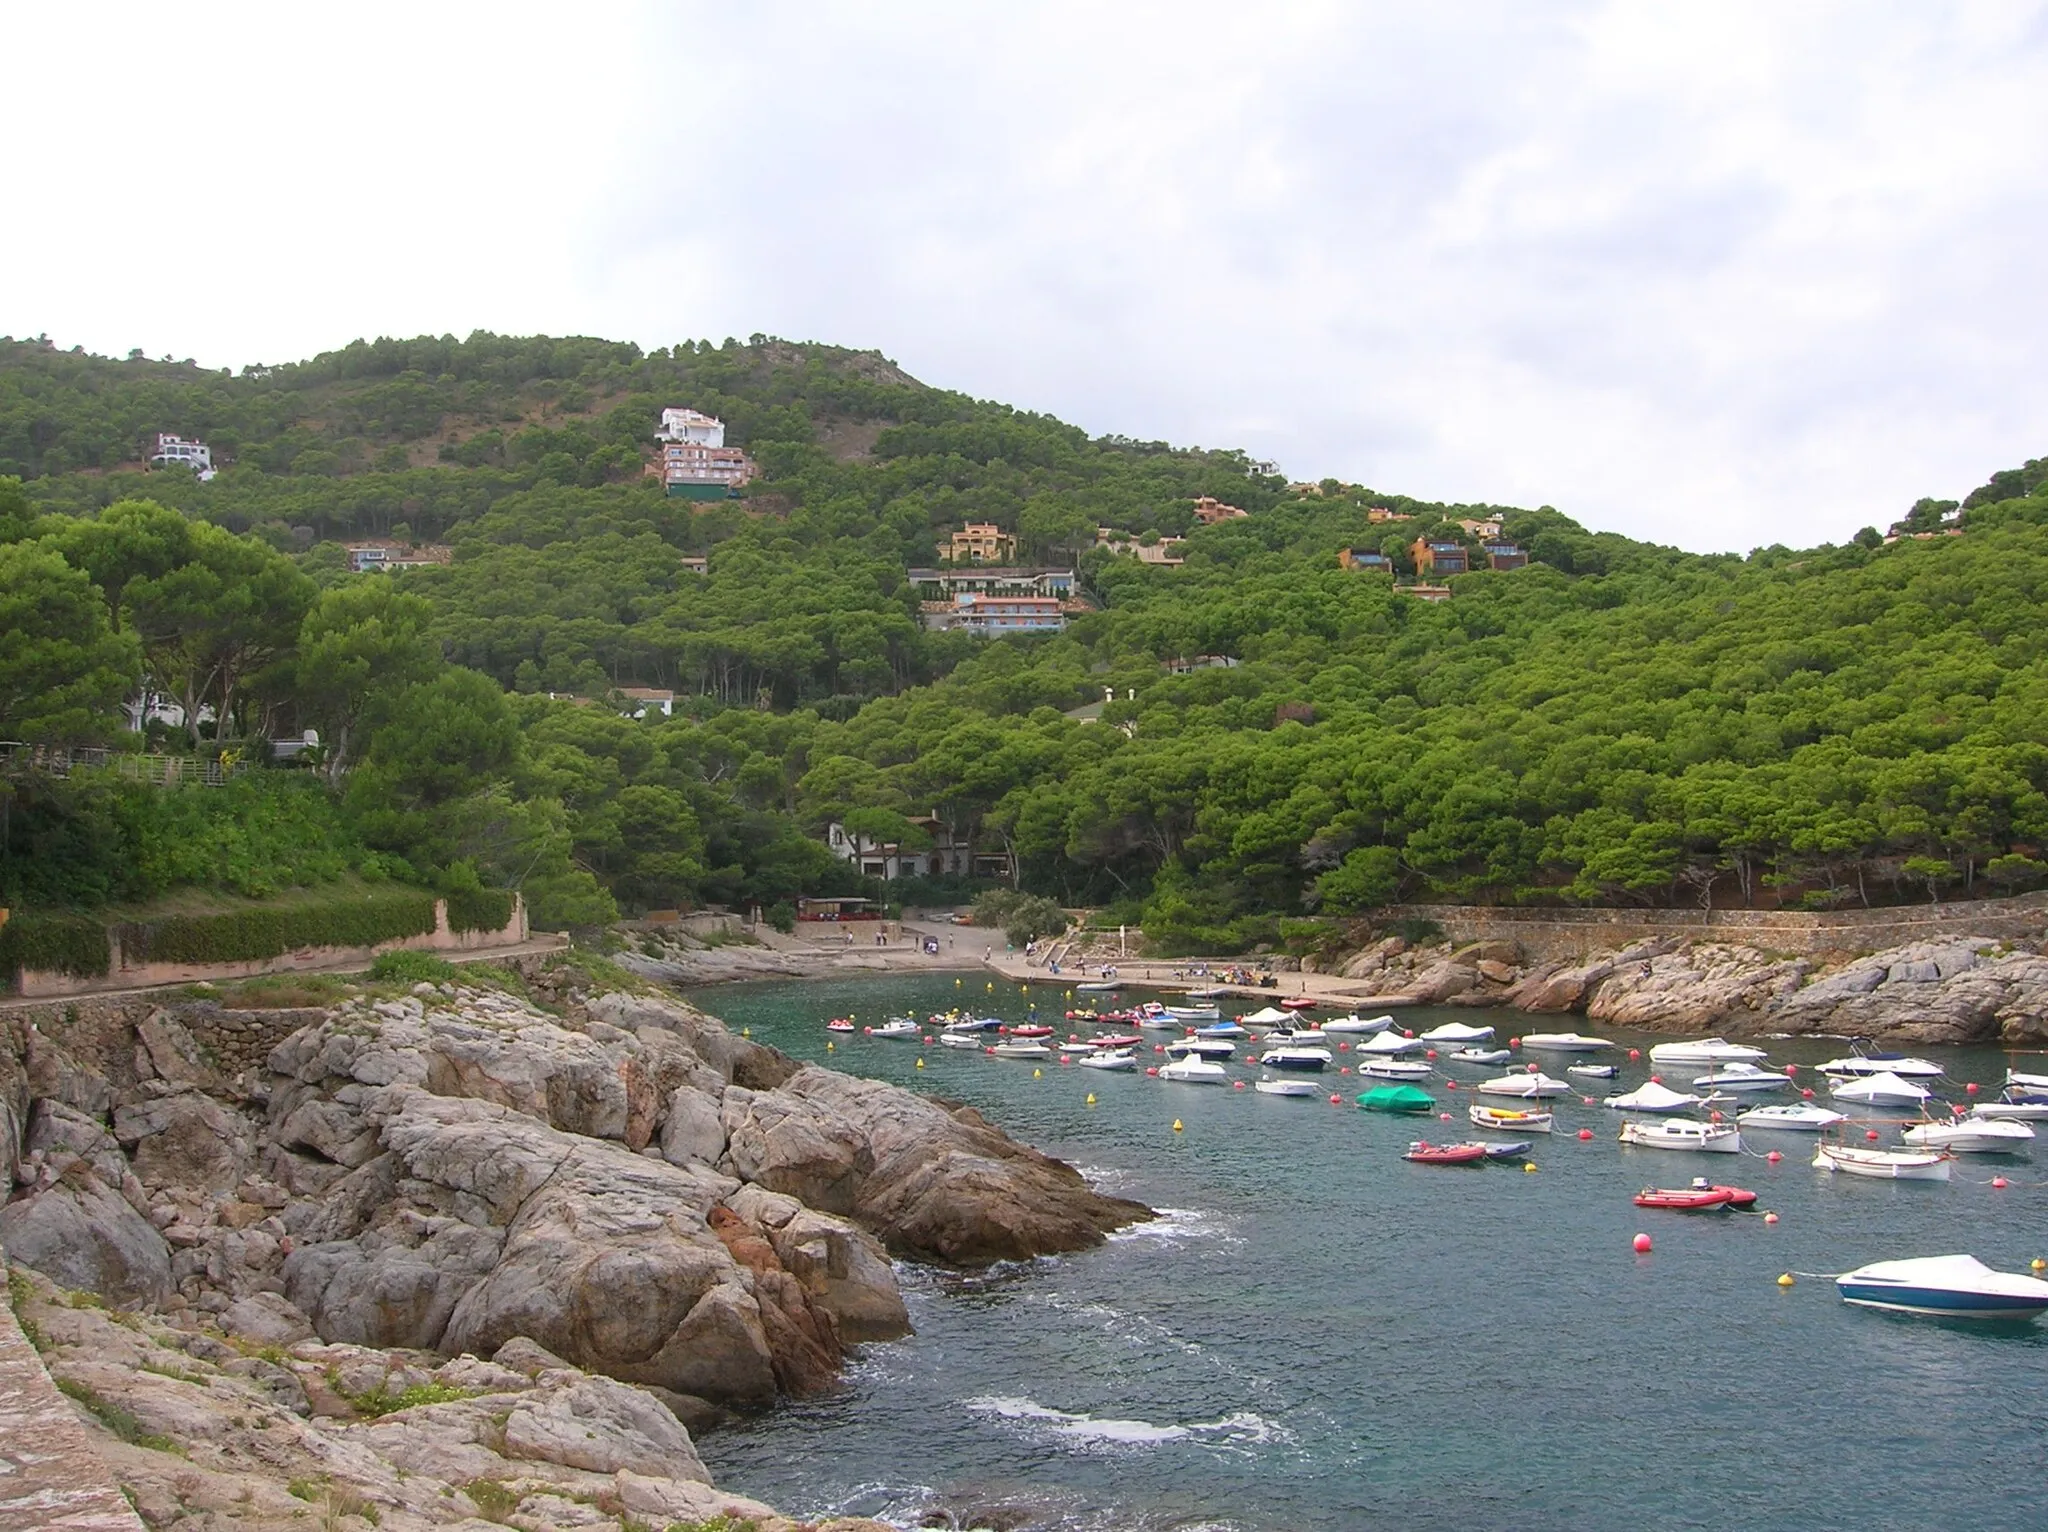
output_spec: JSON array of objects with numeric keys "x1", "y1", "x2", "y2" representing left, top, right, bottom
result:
[{"x1": 0, "y1": 0, "x2": 2048, "y2": 549}]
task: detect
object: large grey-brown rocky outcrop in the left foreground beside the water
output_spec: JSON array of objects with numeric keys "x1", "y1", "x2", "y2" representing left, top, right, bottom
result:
[{"x1": 0, "y1": 983, "x2": 1153, "y2": 1532}]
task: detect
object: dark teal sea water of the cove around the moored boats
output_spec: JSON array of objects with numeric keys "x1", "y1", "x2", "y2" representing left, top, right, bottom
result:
[{"x1": 692, "y1": 975, "x2": 2048, "y2": 1532}]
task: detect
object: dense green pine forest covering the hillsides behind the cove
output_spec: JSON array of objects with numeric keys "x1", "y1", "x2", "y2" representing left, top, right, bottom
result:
[{"x1": 0, "y1": 334, "x2": 2048, "y2": 950}]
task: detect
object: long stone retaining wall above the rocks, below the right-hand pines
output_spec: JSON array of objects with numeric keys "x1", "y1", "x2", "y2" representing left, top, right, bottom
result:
[{"x1": 1374, "y1": 893, "x2": 2048, "y2": 963}]
